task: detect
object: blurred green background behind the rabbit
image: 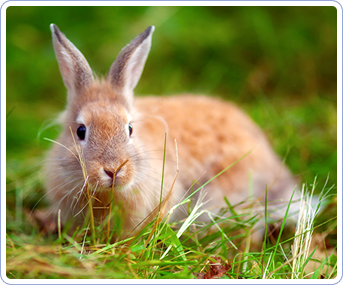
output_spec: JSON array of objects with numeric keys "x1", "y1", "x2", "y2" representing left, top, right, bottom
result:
[{"x1": 6, "y1": 7, "x2": 337, "y2": 193}]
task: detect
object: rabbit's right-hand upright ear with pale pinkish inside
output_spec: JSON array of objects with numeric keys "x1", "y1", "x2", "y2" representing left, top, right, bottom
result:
[{"x1": 108, "y1": 26, "x2": 155, "y2": 103}]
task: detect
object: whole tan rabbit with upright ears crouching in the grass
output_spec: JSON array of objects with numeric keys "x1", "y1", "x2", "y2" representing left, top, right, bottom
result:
[{"x1": 45, "y1": 24, "x2": 296, "y2": 239}]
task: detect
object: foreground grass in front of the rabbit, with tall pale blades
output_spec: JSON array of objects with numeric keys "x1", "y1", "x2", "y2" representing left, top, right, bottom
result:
[{"x1": 6, "y1": 141, "x2": 337, "y2": 279}]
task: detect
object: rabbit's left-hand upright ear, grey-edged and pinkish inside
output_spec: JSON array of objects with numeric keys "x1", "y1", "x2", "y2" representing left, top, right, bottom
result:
[{"x1": 50, "y1": 24, "x2": 93, "y2": 100}]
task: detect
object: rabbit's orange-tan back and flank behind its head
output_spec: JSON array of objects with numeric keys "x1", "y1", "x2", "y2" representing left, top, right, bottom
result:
[{"x1": 134, "y1": 94, "x2": 296, "y2": 218}]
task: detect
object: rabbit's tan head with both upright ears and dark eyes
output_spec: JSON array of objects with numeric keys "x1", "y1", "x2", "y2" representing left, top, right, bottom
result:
[{"x1": 51, "y1": 24, "x2": 154, "y2": 190}]
